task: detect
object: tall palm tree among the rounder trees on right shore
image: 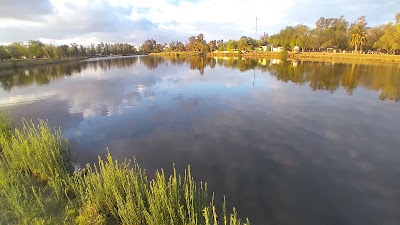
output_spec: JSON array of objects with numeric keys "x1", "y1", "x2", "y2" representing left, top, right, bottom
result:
[{"x1": 349, "y1": 16, "x2": 367, "y2": 53}]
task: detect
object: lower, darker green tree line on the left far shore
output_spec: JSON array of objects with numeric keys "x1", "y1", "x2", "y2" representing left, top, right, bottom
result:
[{"x1": 0, "y1": 40, "x2": 138, "y2": 61}]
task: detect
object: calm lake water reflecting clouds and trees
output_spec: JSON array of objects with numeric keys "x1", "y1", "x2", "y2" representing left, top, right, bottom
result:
[{"x1": 0, "y1": 56, "x2": 400, "y2": 225}]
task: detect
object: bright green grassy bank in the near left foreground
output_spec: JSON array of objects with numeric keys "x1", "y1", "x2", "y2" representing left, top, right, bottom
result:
[{"x1": 0, "y1": 113, "x2": 249, "y2": 225}]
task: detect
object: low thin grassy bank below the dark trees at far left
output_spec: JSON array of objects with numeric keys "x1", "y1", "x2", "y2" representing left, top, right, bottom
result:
[{"x1": 0, "y1": 57, "x2": 88, "y2": 69}]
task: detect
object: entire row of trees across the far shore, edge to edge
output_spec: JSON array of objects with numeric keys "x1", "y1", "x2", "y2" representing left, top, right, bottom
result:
[{"x1": 0, "y1": 13, "x2": 400, "y2": 62}]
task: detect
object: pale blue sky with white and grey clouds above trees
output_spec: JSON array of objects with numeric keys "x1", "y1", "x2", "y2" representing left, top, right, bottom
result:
[{"x1": 0, "y1": 0, "x2": 400, "y2": 46}]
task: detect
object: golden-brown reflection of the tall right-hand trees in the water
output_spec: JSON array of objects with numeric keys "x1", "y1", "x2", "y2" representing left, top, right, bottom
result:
[{"x1": 262, "y1": 62, "x2": 400, "y2": 102}]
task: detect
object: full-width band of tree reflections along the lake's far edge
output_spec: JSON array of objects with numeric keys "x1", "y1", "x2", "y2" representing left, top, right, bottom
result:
[{"x1": 0, "y1": 56, "x2": 400, "y2": 102}]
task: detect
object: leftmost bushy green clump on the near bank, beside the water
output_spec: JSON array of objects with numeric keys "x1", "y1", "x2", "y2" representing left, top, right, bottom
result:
[{"x1": 0, "y1": 120, "x2": 73, "y2": 181}]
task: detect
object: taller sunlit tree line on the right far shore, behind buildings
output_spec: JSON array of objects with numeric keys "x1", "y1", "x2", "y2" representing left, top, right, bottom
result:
[{"x1": 140, "y1": 13, "x2": 400, "y2": 54}]
